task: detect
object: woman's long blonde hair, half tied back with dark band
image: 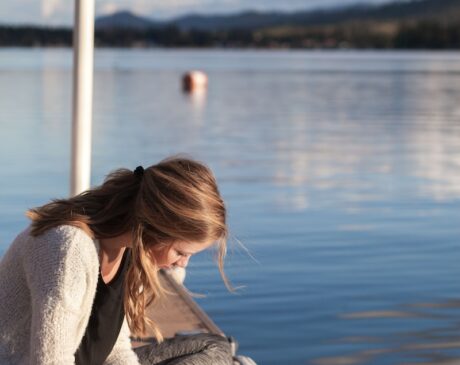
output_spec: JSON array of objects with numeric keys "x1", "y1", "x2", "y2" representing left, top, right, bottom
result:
[{"x1": 27, "y1": 156, "x2": 230, "y2": 341}]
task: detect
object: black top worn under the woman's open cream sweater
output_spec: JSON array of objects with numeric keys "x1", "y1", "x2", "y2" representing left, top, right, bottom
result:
[{"x1": 75, "y1": 248, "x2": 130, "y2": 365}]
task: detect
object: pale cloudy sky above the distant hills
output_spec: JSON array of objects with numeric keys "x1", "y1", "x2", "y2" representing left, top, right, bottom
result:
[{"x1": 0, "y1": 0, "x2": 396, "y2": 26}]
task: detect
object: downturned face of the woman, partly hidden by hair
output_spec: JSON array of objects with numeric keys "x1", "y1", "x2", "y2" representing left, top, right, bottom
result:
[{"x1": 153, "y1": 242, "x2": 212, "y2": 269}]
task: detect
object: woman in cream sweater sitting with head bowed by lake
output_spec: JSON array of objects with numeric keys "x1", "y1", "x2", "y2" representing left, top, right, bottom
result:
[{"x1": 0, "y1": 157, "x2": 232, "y2": 365}]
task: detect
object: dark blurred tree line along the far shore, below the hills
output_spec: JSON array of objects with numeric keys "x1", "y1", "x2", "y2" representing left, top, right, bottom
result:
[{"x1": 0, "y1": 20, "x2": 460, "y2": 49}]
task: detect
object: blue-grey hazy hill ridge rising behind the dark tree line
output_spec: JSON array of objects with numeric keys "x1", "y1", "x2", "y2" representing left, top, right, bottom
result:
[{"x1": 96, "y1": 0, "x2": 460, "y2": 31}]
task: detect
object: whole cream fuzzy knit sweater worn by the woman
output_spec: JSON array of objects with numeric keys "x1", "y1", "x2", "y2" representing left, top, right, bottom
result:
[{"x1": 0, "y1": 226, "x2": 139, "y2": 365}]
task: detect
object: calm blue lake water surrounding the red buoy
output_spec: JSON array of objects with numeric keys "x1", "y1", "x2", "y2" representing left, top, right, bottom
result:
[{"x1": 0, "y1": 49, "x2": 460, "y2": 365}]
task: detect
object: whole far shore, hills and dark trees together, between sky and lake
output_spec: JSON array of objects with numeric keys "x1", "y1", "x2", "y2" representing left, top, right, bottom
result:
[{"x1": 0, "y1": 0, "x2": 460, "y2": 50}]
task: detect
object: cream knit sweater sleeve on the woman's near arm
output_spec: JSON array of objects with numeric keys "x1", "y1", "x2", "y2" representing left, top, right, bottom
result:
[{"x1": 24, "y1": 229, "x2": 97, "y2": 365}]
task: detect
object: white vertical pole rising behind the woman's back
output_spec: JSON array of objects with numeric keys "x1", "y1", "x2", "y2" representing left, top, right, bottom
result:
[{"x1": 70, "y1": 0, "x2": 94, "y2": 196}]
